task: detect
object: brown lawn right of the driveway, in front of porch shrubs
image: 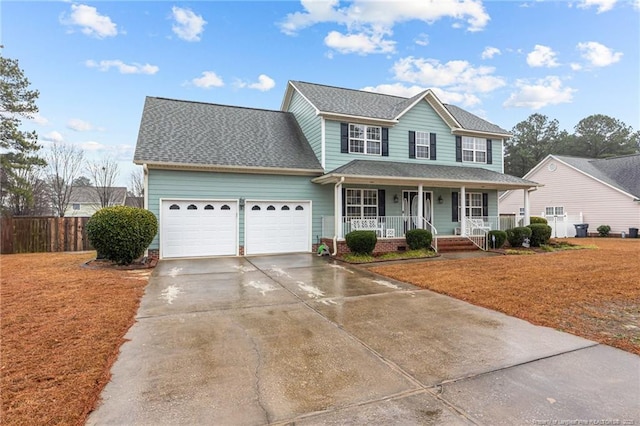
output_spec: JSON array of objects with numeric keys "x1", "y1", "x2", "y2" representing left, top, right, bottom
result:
[{"x1": 372, "y1": 238, "x2": 640, "y2": 355}]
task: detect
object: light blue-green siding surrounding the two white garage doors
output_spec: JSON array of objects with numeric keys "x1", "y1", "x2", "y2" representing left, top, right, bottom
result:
[{"x1": 148, "y1": 169, "x2": 334, "y2": 249}]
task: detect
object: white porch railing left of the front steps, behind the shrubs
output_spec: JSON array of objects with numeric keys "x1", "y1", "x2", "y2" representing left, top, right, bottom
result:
[{"x1": 322, "y1": 216, "x2": 438, "y2": 251}]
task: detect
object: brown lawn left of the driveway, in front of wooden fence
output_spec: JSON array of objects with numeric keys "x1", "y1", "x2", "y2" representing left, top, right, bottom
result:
[{"x1": 0, "y1": 252, "x2": 151, "y2": 425}]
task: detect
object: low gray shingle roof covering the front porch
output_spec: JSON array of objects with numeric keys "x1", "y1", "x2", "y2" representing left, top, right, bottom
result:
[{"x1": 314, "y1": 160, "x2": 539, "y2": 188}]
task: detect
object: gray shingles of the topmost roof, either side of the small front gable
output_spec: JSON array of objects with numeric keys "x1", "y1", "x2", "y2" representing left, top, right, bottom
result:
[{"x1": 291, "y1": 81, "x2": 509, "y2": 134}]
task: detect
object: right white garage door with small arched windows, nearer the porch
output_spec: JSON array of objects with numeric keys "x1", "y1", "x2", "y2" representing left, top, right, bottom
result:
[{"x1": 244, "y1": 201, "x2": 311, "y2": 254}]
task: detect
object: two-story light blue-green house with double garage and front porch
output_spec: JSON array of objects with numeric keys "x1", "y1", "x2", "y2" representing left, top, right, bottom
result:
[{"x1": 134, "y1": 81, "x2": 537, "y2": 258}]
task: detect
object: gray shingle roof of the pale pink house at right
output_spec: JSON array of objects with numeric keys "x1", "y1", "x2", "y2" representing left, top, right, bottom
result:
[{"x1": 554, "y1": 154, "x2": 640, "y2": 198}]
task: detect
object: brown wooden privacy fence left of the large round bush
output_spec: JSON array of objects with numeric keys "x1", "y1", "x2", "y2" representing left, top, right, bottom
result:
[{"x1": 0, "y1": 216, "x2": 93, "y2": 254}]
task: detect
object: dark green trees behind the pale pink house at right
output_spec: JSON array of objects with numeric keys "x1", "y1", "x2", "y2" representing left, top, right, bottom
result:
[{"x1": 504, "y1": 114, "x2": 640, "y2": 177}]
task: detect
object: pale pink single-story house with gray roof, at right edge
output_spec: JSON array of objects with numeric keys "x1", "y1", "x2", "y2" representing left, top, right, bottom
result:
[{"x1": 500, "y1": 154, "x2": 640, "y2": 237}]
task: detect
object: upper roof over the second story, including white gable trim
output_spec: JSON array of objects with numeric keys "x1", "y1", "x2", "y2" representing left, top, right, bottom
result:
[{"x1": 282, "y1": 81, "x2": 510, "y2": 137}]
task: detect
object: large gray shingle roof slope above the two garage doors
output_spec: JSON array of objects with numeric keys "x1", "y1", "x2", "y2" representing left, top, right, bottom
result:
[{"x1": 133, "y1": 97, "x2": 322, "y2": 173}]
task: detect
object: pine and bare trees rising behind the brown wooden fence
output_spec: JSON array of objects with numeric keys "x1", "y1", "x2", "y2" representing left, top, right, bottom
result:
[{"x1": 0, "y1": 46, "x2": 143, "y2": 217}]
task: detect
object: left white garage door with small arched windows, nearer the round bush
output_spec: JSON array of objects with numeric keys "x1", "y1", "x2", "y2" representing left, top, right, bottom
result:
[{"x1": 160, "y1": 200, "x2": 238, "y2": 258}]
